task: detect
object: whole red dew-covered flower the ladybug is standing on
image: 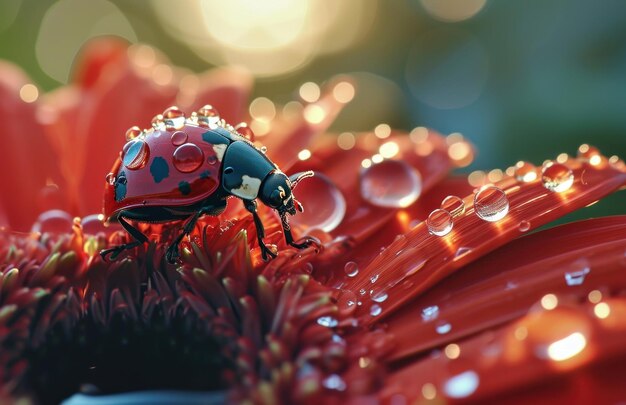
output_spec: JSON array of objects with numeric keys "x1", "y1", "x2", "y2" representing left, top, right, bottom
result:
[{"x1": 0, "y1": 40, "x2": 626, "y2": 403}]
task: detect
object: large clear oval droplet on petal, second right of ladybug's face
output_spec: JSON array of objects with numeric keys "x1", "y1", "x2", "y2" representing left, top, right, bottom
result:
[{"x1": 361, "y1": 160, "x2": 422, "y2": 208}]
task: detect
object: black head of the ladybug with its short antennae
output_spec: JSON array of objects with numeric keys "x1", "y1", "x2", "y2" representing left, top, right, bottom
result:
[{"x1": 259, "y1": 171, "x2": 313, "y2": 215}]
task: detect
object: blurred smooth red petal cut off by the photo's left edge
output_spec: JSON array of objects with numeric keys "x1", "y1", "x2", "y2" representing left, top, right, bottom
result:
[{"x1": 0, "y1": 62, "x2": 60, "y2": 230}]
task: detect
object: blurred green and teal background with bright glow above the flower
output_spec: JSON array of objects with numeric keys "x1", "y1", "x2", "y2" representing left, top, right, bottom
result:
[{"x1": 0, "y1": 0, "x2": 626, "y2": 220}]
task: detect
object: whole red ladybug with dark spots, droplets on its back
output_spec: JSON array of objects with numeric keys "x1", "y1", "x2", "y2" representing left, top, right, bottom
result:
[{"x1": 100, "y1": 105, "x2": 313, "y2": 263}]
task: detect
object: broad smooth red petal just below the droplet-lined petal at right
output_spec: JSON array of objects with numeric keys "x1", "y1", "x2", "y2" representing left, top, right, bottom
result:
[{"x1": 386, "y1": 216, "x2": 626, "y2": 361}]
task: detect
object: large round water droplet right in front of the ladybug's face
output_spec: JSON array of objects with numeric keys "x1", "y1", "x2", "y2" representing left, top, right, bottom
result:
[{"x1": 291, "y1": 172, "x2": 346, "y2": 232}]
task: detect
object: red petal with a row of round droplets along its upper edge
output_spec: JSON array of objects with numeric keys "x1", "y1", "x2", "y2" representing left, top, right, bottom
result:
[{"x1": 347, "y1": 155, "x2": 626, "y2": 319}]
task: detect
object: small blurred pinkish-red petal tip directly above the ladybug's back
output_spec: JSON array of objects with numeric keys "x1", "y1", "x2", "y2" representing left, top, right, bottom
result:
[{"x1": 180, "y1": 67, "x2": 254, "y2": 125}]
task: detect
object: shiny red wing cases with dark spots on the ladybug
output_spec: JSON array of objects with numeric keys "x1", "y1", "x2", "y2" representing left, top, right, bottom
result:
[{"x1": 104, "y1": 124, "x2": 228, "y2": 218}]
